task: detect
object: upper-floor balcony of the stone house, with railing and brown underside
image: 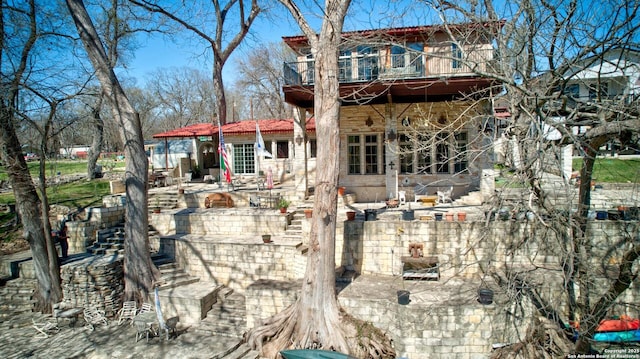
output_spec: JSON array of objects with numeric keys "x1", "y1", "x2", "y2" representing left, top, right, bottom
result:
[{"x1": 283, "y1": 49, "x2": 493, "y2": 108}]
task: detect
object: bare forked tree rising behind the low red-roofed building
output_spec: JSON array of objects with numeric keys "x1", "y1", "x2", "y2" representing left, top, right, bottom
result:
[{"x1": 130, "y1": 0, "x2": 260, "y2": 124}]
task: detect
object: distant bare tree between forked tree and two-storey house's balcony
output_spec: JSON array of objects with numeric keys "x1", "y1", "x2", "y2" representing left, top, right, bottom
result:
[{"x1": 236, "y1": 43, "x2": 293, "y2": 118}]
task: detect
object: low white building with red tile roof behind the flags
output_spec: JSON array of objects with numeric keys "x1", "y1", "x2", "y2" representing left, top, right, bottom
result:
[{"x1": 152, "y1": 119, "x2": 316, "y2": 187}]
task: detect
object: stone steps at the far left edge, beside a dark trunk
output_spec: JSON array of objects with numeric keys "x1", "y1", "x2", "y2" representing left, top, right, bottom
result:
[{"x1": 0, "y1": 278, "x2": 37, "y2": 319}]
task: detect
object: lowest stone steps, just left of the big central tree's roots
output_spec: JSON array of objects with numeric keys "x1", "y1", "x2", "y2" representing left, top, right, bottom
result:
[{"x1": 196, "y1": 286, "x2": 247, "y2": 339}]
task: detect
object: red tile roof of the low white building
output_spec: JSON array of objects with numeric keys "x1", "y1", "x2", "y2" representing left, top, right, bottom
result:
[{"x1": 153, "y1": 118, "x2": 316, "y2": 138}]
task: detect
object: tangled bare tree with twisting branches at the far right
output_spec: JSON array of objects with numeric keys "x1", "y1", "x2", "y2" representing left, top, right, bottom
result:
[{"x1": 418, "y1": 0, "x2": 640, "y2": 357}]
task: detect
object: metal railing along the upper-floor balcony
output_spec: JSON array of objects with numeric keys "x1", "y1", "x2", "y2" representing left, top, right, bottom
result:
[{"x1": 283, "y1": 49, "x2": 493, "y2": 85}]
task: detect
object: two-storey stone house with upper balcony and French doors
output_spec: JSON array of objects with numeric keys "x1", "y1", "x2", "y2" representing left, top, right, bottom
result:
[{"x1": 283, "y1": 22, "x2": 502, "y2": 201}]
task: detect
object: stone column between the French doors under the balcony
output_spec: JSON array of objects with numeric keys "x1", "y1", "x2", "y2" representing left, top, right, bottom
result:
[{"x1": 384, "y1": 103, "x2": 400, "y2": 198}]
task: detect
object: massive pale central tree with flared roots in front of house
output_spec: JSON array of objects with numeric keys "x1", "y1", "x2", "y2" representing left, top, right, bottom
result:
[{"x1": 247, "y1": 0, "x2": 395, "y2": 358}]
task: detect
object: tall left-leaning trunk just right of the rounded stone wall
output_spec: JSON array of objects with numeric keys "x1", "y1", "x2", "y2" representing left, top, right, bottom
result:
[{"x1": 67, "y1": 0, "x2": 158, "y2": 302}]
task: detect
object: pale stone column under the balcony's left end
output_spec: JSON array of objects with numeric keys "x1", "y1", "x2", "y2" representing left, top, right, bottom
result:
[{"x1": 292, "y1": 107, "x2": 308, "y2": 200}]
